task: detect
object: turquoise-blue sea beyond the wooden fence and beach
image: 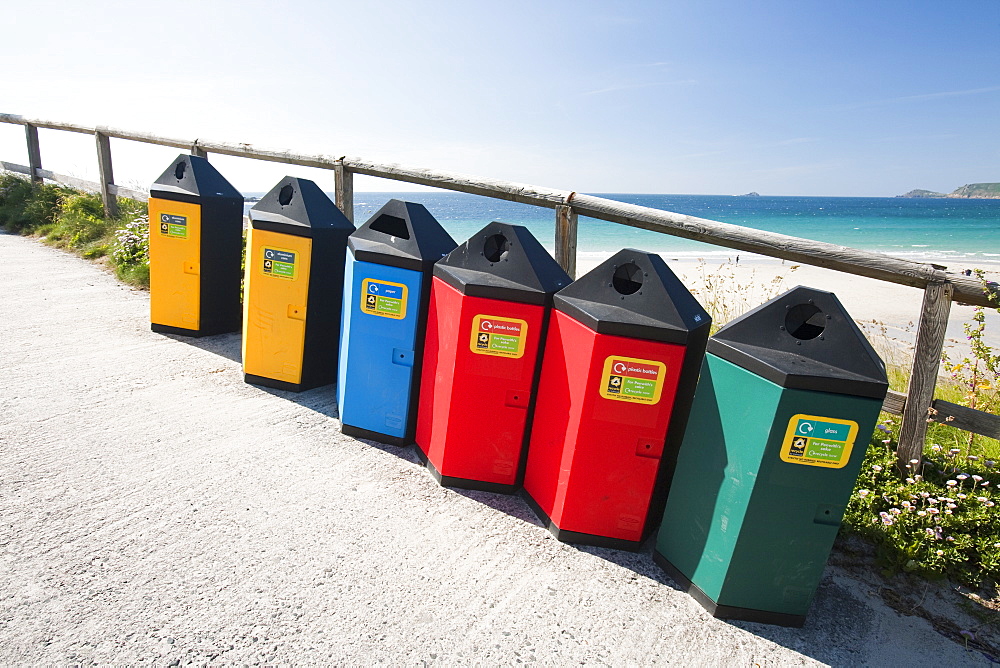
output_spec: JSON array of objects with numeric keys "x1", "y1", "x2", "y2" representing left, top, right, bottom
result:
[{"x1": 247, "y1": 192, "x2": 1000, "y2": 271}]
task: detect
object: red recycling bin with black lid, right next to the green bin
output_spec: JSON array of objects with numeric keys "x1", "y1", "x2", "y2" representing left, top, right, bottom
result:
[{"x1": 524, "y1": 249, "x2": 712, "y2": 550}]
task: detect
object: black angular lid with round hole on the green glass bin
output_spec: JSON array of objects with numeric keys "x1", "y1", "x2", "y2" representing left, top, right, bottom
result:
[{"x1": 708, "y1": 286, "x2": 889, "y2": 399}]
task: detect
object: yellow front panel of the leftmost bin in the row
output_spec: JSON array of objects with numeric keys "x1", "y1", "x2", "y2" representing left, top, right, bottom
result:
[{"x1": 149, "y1": 197, "x2": 202, "y2": 330}]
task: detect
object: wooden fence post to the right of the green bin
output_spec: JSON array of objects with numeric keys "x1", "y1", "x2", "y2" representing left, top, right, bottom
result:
[{"x1": 896, "y1": 283, "x2": 955, "y2": 471}]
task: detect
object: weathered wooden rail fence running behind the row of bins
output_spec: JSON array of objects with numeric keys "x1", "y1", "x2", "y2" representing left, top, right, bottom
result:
[{"x1": 0, "y1": 114, "x2": 1000, "y2": 463}]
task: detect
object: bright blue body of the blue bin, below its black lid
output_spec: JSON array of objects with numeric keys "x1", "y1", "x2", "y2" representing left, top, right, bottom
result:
[{"x1": 337, "y1": 253, "x2": 425, "y2": 439}]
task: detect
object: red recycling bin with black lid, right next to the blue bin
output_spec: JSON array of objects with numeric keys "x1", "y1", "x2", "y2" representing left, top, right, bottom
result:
[{"x1": 416, "y1": 222, "x2": 570, "y2": 492}]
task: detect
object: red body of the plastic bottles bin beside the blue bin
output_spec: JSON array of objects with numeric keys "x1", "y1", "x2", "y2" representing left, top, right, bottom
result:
[{"x1": 416, "y1": 277, "x2": 546, "y2": 486}]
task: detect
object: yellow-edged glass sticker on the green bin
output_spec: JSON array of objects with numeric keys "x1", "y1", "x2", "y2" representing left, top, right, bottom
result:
[{"x1": 781, "y1": 414, "x2": 858, "y2": 469}]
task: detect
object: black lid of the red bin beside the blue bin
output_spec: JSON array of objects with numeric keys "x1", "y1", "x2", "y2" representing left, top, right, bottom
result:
[{"x1": 434, "y1": 221, "x2": 571, "y2": 306}]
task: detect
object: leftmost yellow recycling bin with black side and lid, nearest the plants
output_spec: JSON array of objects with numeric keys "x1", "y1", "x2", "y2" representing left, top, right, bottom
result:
[{"x1": 149, "y1": 154, "x2": 243, "y2": 336}]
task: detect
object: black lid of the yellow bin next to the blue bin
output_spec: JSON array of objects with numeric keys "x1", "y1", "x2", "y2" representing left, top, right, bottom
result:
[{"x1": 250, "y1": 176, "x2": 354, "y2": 237}]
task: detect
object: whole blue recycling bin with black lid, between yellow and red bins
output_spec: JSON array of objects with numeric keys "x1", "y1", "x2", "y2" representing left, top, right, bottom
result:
[{"x1": 337, "y1": 199, "x2": 456, "y2": 445}]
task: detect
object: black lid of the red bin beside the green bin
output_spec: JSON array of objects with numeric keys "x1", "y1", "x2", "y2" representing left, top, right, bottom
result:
[{"x1": 554, "y1": 248, "x2": 712, "y2": 344}]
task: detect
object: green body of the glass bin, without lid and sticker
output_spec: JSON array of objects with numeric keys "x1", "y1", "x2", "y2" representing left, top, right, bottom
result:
[{"x1": 656, "y1": 354, "x2": 882, "y2": 617}]
